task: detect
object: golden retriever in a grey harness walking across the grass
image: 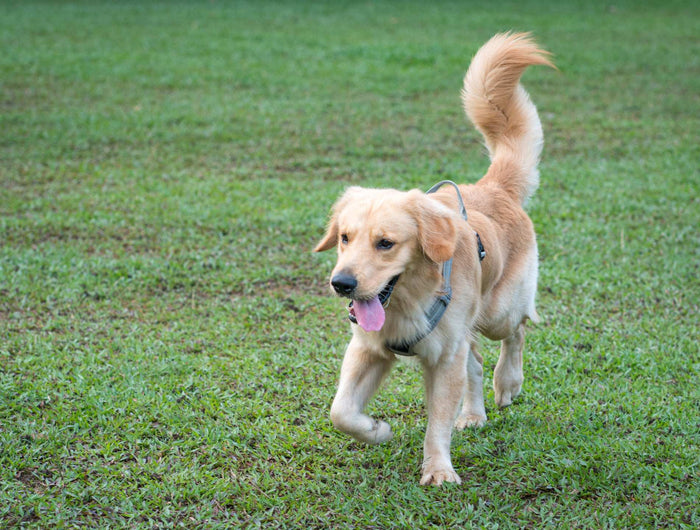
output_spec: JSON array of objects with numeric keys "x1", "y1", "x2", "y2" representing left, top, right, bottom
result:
[{"x1": 314, "y1": 33, "x2": 554, "y2": 486}]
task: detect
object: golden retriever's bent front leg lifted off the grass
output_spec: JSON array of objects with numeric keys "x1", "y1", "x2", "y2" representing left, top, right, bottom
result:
[{"x1": 331, "y1": 338, "x2": 393, "y2": 444}]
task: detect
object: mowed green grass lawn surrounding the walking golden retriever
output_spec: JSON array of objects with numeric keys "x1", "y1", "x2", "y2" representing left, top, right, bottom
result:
[{"x1": 0, "y1": 0, "x2": 700, "y2": 528}]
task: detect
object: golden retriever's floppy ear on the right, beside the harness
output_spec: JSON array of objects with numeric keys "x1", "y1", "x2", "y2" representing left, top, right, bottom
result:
[{"x1": 409, "y1": 190, "x2": 457, "y2": 263}]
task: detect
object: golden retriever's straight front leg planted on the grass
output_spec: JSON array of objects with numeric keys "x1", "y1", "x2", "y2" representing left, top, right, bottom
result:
[{"x1": 420, "y1": 342, "x2": 468, "y2": 486}]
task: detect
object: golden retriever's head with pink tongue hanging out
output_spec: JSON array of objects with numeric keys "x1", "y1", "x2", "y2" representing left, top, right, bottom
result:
[{"x1": 314, "y1": 187, "x2": 458, "y2": 331}]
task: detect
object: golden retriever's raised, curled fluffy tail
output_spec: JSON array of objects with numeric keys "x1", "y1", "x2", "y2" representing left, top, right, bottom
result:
[{"x1": 462, "y1": 33, "x2": 554, "y2": 204}]
